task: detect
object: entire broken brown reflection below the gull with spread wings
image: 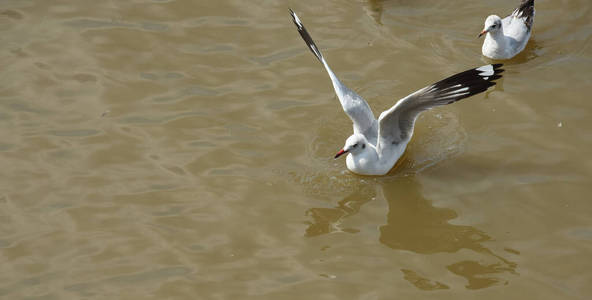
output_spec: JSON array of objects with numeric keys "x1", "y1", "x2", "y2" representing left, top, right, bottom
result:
[{"x1": 306, "y1": 176, "x2": 517, "y2": 290}]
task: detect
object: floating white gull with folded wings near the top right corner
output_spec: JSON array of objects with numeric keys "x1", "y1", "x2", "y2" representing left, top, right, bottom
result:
[{"x1": 479, "y1": 0, "x2": 535, "y2": 59}]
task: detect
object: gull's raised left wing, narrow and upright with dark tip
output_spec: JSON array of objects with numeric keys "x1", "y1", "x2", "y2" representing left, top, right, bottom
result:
[{"x1": 290, "y1": 9, "x2": 377, "y2": 138}]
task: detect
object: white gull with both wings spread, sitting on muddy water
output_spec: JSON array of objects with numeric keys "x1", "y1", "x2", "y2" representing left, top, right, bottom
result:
[{"x1": 290, "y1": 9, "x2": 503, "y2": 175}]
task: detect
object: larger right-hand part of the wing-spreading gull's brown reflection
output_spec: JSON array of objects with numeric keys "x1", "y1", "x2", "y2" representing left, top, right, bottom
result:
[{"x1": 380, "y1": 179, "x2": 516, "y2": 289}]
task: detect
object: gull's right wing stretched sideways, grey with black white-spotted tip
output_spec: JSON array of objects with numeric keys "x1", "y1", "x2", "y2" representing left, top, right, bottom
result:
[{"x1": 378, "y1": 64, "x2": 504, "y2": 153}]
